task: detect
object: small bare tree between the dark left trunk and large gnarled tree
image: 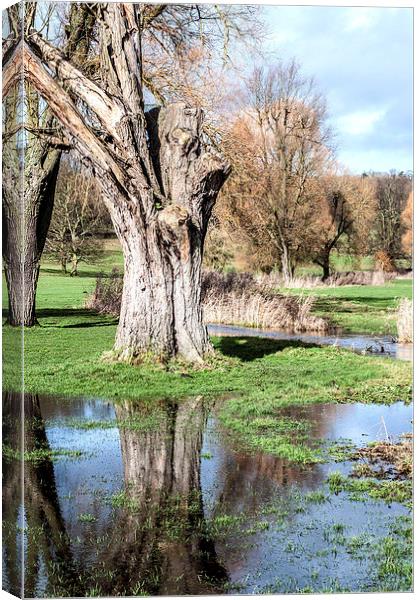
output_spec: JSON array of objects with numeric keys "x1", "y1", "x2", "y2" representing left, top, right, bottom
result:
[{"x1": 46, "y1": 161, "x2": 108, "y2": 276}]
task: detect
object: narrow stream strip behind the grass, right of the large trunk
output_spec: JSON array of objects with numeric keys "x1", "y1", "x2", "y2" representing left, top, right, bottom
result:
[{"x1": 208, "y1": 324, "x2": 413, "y2": 361}]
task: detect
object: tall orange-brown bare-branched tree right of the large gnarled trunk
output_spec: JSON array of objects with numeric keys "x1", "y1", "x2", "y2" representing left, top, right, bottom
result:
[{"x1": 223, "y1": 61, "x2": 331, "y2": 281}]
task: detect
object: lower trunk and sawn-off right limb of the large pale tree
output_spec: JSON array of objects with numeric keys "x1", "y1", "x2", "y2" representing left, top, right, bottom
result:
[{"x1": 104, "y1": 104, "x2": 228, "y2": 362}]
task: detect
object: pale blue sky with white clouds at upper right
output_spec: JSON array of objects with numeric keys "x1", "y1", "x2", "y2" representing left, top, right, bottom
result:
[{"x1": 264, "y1": 6, "x2": 413, "y2": 173}]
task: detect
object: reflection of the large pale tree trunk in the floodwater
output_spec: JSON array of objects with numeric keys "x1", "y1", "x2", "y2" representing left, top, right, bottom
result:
[{"x1": 101, "y1": 398, "x2": 226, "y2": 595}]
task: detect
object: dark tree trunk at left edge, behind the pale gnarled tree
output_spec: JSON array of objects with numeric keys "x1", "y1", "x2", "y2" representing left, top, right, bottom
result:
[{"x1": 3, "y1": 2, "x2": 93, "y2": 326}]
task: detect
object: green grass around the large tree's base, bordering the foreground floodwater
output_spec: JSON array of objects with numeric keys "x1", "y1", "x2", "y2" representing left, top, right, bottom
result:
[{"x1": 3, "y1": 253, "x2": 411, "y2": 463}]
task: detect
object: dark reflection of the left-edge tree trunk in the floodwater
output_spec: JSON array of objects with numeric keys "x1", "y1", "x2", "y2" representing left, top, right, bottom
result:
[{"x1": 3, "y1": 392, "x2": 77, "y2": 597}]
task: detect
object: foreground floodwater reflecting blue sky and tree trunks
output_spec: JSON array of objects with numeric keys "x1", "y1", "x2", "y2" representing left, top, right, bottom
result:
[{"x1": 3, "y1": 394, "x2": 412, "y2": 597}]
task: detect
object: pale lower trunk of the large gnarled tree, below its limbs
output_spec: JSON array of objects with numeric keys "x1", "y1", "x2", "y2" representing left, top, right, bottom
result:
[{"x1": 115, "y1": 206, "x2": 210, "y2": 361}]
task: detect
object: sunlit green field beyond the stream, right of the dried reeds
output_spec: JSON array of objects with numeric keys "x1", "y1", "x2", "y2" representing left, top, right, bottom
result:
[{"x1": 281, "y1": 279, "x2": 413, "y2": 335}]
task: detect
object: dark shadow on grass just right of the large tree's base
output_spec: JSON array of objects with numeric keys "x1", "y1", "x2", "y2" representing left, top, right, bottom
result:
[{"x1": 214, "y1": 336, "x2": 319, "y2": 362}]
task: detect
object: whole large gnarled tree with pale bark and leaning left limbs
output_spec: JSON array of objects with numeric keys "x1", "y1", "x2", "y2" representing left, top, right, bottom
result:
[{"x1": 16, "y1": 3, "x2": 229, "y2": 361}]
